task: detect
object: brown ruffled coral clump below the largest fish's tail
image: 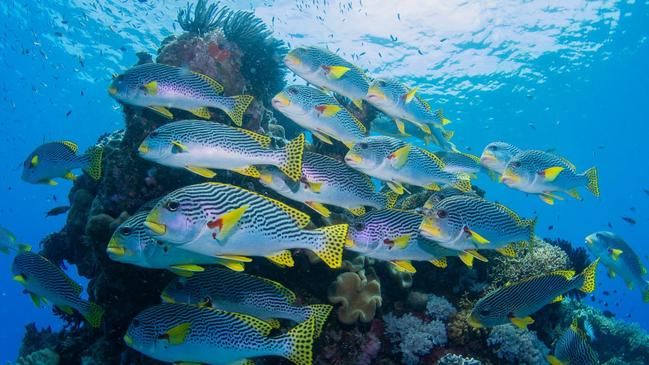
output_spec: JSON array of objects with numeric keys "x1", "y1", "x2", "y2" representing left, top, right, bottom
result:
[{"x1": 329, "y1": 270, "x2": 382, "y2": 324}]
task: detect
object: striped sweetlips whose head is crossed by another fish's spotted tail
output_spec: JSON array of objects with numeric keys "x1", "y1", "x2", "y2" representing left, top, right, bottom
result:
[{"x1": 259, "y1": 152, "x2": 397, "y2": 217}]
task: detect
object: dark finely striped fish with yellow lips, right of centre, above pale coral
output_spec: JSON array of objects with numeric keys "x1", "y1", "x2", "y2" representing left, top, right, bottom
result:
[{"x1": 420, "y1": 195, "x2": 536, "y2": 263}]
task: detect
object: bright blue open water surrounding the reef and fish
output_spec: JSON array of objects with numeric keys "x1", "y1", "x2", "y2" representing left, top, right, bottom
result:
[{"x1": 0, "y1": 0, "x2": 649, "y2": 362}]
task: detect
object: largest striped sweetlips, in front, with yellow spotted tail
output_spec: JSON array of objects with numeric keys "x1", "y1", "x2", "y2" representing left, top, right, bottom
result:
[{"x1": 144, "y1": 183, "x2": 347, "y2": 268}]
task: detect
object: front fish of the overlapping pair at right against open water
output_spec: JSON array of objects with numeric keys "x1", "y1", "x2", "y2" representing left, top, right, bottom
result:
[{"x1": 501, "y1": 150, "x2": 599, "y2": 205}]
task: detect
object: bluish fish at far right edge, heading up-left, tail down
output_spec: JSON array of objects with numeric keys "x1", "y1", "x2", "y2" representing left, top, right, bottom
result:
[{"x1": 585, "y1": 231, "x2": 649, "y2": 302}]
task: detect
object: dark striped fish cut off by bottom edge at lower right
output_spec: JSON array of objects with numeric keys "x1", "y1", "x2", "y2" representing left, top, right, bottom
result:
[{"x1": 546, "y1": 318, "x2": 599, "y2": 365}]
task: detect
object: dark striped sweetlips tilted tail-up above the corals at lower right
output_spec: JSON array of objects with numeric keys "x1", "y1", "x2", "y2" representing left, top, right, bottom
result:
[{"x1": 468, "y1": 259, "x2": 599, "y2": 328}]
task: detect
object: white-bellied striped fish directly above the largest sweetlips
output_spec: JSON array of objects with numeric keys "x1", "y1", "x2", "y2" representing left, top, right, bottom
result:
[{"x1": 138, "y1": 120, "x2": 304, "y2": 180}]
